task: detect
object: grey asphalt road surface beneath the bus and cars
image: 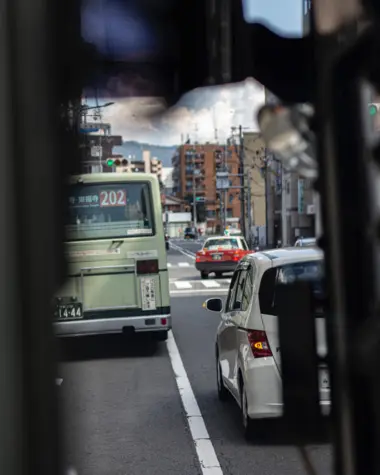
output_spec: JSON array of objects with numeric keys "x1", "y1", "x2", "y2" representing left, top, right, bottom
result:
[{"x1": 59, "y1": 241, "x2": 332, "y2": 475}]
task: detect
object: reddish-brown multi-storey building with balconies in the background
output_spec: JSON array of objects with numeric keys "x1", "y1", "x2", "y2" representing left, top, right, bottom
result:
[{"x1": 172, "y1": 144, "x2": 240, "y2": 232}]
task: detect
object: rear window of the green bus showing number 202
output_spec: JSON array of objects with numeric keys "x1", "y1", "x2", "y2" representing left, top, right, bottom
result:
[{"x1": 65, "y1": 182, "x2": 154, "y2": 241}]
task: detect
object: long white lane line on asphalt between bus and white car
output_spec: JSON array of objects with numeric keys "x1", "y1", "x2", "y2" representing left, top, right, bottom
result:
[{"x1": 166, "y1": 331, "x2": 223, "y2": 475}]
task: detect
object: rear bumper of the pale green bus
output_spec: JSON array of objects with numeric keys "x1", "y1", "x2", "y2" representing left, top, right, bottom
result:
[{"x1": 53, "y1": 315, "x2": 172, "y2": 337}]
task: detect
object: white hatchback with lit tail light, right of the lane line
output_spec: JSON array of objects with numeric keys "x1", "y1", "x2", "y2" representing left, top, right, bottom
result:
[{"x1": 204, "y1": 247, "x2": 330, "y2": 437}]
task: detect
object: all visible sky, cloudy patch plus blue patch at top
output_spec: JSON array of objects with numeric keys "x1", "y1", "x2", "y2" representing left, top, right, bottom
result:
[{"x1": 84, "y1": 0, "x2": 303, "y2": 145}]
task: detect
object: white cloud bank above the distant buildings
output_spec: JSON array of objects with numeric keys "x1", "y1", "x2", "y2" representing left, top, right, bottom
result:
[{"x1": 103, "y1": 80, "x2": 264, "y2": 145}]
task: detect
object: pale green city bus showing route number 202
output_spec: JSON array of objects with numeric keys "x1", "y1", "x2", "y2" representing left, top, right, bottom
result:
[{"x1": 54, "y1": 173, "x2": 172, "y2": 341}]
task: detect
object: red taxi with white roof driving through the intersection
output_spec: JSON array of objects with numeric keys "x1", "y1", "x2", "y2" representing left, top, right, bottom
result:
[{"x1": 195, "y1": 236, "x2": 254, "y2": 279}]
